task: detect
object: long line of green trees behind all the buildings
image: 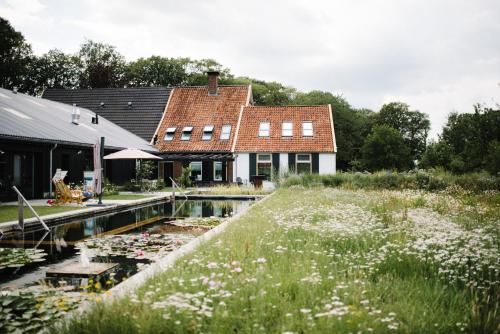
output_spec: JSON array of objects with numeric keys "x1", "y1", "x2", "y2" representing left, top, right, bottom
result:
[{"x1": 0, "y1": 18, "x2": 500, "y2": 174}]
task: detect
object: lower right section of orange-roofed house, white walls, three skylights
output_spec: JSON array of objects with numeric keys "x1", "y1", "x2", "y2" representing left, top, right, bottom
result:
[{"x1": 233, "y1": 105, "x2": 337, "y2": 183}]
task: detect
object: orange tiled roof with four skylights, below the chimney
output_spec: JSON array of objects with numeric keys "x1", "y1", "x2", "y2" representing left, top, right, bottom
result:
[{"x1": 156, "y1": 86, "x2": 251, "y2": 152}]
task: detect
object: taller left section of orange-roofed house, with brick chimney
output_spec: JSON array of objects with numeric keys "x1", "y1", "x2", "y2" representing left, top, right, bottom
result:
[{"x1": 153, "y1": 72, "x2": 253, "y2": 184}]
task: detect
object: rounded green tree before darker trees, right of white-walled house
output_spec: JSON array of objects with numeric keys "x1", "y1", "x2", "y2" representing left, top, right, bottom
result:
[{"x1": 361, "y1": 125, "x2": 412, "y2": 171}]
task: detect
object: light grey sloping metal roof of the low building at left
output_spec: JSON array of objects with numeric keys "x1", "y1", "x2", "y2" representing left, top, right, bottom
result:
[{"x1": 0, "y1": 88, "x2": 156, "y2": 152}]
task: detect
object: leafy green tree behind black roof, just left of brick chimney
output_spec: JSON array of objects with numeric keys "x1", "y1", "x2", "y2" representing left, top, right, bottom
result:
[{"x1": 126, "y1": 56, "x2": 191, "y2": 87}]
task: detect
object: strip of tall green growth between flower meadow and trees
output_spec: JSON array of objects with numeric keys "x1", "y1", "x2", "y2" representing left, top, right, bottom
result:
[{"x1": 281, "y1": 170, "x2": 500, "y2": 193}]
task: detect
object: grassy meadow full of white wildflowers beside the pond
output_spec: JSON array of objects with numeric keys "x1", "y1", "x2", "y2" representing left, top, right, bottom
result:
[{"x1": 60, "y1": 187, "x2": 500, "y2": 334}]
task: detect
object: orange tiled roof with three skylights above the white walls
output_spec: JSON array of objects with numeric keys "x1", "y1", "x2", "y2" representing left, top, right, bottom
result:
[{"x1": 234, "y1": 105, "x2": 335, "y2": 152}]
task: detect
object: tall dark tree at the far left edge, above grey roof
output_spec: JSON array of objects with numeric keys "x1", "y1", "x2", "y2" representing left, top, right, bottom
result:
[{"x1": 0, "y1": 17, "x2": 33, "y2": 91}]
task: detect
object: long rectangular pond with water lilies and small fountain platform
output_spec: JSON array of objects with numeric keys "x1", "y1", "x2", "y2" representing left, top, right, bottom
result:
[{"x1": 0, "y1": 200, "x2": 253, "y2": 290}]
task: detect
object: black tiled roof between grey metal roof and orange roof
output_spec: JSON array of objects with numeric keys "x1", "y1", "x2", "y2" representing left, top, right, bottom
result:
[{"x1": 42, "y1": 87, "x2": 172, "y2": 142}]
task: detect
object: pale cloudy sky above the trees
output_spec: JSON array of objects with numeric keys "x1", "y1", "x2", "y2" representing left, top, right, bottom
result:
[{"x1": 0, "y1": 0, "x2": 500, "y2": 138}]
